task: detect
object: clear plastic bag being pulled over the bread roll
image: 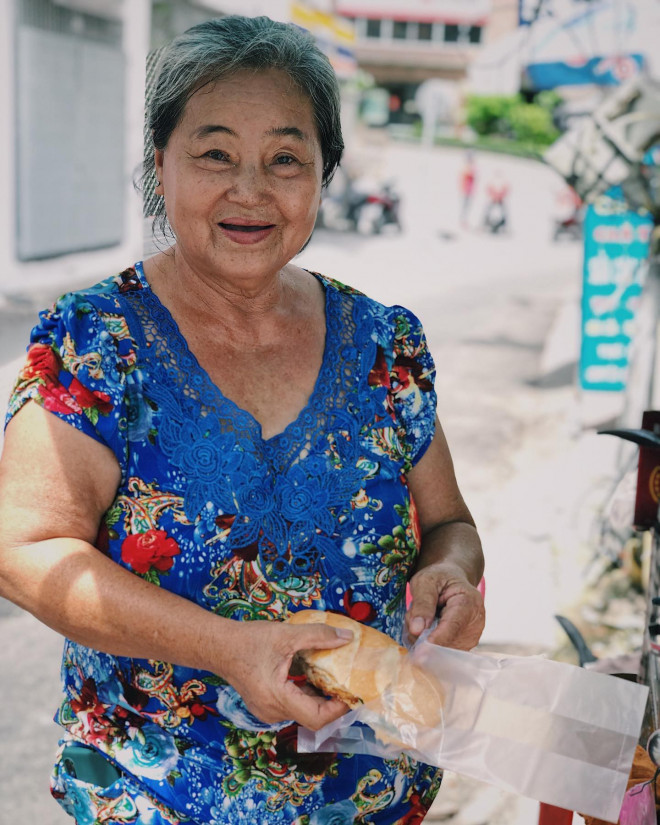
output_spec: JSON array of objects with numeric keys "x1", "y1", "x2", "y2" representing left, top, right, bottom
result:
[{"x1": 298, "y1": 640, "x2": 648, "y2": 822}]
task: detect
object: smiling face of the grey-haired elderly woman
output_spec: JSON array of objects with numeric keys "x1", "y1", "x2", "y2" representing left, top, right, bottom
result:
[{"x1": 155, "y1": 69, "x2": 323, "y2": 285}]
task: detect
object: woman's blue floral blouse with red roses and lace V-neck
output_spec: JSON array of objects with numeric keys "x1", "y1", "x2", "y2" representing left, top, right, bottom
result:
[{"x1": 7, "y1": 264, "x2": 440, "y2": 825}]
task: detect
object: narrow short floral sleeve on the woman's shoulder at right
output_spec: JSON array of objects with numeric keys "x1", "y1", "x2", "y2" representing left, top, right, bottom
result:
[{"x1": 389, "y1": 306, "x2": 437, "y2": 466}]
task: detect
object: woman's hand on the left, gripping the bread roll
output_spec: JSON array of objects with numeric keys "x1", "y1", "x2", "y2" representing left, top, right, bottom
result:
[{"x1": 220, "y1": 621, "x2": 352, "y2": 730}]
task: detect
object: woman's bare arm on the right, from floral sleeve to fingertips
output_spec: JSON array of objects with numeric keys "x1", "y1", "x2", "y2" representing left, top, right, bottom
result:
[{"x1": 406, "y1": 423, "x2": 485, "y2": 650}]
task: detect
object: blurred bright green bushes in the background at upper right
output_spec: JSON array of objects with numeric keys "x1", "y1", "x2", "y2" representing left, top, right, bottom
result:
[{"x1": 466, "y1": 91, "x2": 561, "y2": 146}]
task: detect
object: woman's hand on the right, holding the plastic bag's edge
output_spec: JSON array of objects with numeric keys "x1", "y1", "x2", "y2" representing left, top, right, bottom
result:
[{"x1": 406, "y1": 561, "x2": 486, "y2": 650}]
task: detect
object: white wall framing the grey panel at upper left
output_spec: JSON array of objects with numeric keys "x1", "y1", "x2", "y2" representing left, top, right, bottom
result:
[{"x1": 0, "y1": 0, "x2": 151, "y2": 295}]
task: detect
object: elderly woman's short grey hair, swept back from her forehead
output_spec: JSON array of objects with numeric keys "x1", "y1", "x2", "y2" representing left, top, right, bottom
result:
[{"x1": 141, "y1": 15, "x2": 344, "y2": 237}]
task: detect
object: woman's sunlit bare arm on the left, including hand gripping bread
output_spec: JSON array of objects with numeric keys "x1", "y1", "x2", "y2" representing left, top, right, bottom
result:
[{"x1": 0, "y1": 402, "x2": 346, "y2": 728}]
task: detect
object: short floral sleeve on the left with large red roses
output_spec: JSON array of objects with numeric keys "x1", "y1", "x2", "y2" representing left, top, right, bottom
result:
[{"x1": 5, "y1": 293, "x2": 126, "y2": 473}]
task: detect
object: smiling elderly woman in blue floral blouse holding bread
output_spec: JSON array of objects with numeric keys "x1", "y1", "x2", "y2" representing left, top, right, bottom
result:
[{"x1": 0, "y1": 17, "x2": 484, "y2": 825}]
